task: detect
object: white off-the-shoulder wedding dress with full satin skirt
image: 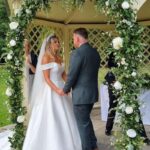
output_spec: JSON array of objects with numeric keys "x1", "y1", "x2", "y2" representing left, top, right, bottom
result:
[{"x1": 23, "y1": 62, "x2": 82, "y2": 150}]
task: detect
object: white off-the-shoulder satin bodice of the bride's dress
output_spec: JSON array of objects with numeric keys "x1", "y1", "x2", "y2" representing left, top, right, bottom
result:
[{"x1": 41, "y1": 62, "x2": 65, "y2": 81}]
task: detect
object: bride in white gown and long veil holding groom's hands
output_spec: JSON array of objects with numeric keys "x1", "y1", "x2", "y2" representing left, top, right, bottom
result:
[{"x1": 23, "y1": 35, "x2": 82, "y2": 150}]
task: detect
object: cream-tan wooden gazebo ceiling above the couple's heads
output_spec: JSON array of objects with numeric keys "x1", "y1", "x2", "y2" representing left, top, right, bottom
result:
[{"x1": 8, "y1": 0, "x2": 150, "y2": 24}]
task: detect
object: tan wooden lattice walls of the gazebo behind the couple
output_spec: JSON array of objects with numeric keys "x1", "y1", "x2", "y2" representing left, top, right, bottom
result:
[{"x1": 27, "y1": 20, "x2": 150, "y2": 70}]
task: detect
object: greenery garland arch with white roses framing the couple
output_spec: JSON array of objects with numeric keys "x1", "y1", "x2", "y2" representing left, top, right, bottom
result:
[{"x1": 6, "y1": 0, "x2": 149, "y2": 150}]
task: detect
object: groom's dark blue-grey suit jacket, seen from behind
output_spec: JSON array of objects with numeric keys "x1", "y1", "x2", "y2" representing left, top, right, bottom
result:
[{"x1": 63, "y1": 43, "x2": 100, "y2": 105}]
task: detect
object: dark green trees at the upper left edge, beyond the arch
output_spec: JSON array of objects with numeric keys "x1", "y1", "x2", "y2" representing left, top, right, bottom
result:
[{"x1": 0, "y1": 0, "x2": 9, "y2": 63}]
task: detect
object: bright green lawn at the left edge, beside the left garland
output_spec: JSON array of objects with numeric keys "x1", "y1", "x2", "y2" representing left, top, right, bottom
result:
[{"x1": 0, "y1": 65, "x2": 11, "y2": 127}]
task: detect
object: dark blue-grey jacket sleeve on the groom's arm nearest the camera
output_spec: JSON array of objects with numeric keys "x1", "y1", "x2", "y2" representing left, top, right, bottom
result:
[{"x1": 63, "y1": 51, "x2": 82, "y2": 93}]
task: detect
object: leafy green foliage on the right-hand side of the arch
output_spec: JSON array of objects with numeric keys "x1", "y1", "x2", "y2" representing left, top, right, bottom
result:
[{"x1": 95, "y1": 0, "x2": 150, "y2": 150}]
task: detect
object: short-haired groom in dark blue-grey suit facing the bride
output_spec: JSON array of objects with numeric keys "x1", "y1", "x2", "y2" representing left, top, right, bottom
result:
[{"x1": 62, "y1": 28, "x2": 100, "y2": 150}]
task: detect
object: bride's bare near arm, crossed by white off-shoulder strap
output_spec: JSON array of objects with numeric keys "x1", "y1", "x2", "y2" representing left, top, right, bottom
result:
[{"x1": 42, "y1": 56, "x2": 62, "y2": 95}]
